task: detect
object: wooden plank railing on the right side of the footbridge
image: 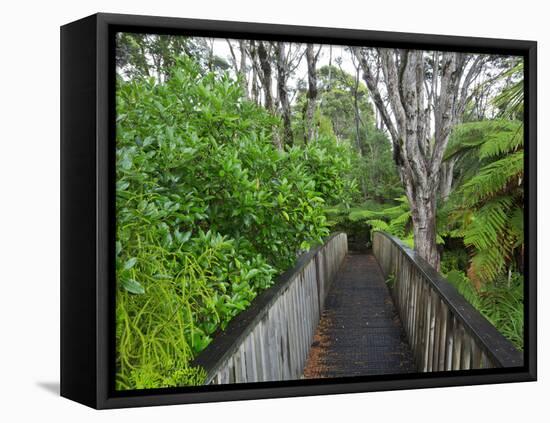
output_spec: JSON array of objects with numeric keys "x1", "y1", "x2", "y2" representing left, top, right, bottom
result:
[{"x1": 373, "y1": 232, "x2": 523, "y2": 372}]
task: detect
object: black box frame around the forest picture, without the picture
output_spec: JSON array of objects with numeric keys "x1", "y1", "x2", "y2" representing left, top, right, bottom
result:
[{"x1": 61, "y1": 13, "x2": 537, "y2": 409}]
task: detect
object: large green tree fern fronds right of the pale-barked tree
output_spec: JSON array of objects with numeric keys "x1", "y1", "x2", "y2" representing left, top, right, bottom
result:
[{"x1": 443, "y1": 120, "x2": 524, "y2": 287}]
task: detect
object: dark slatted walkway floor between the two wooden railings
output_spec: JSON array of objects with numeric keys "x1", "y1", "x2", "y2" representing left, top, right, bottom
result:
[{"x1": 303, "y1": 253, "x2": 416, "y2": 378}]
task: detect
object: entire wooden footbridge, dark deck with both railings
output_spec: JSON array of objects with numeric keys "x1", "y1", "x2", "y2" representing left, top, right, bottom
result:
[{"x1": 197, "y1": 232, "x2": 523, "y2": 384}]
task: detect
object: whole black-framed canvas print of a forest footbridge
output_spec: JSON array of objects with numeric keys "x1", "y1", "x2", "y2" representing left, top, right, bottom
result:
[{"x1": 61, "y1": 14, "x2": 536, "y2": 408}]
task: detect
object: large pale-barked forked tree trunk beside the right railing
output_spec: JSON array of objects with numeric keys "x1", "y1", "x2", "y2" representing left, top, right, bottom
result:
[{"x1": 354, "y1": 48, "x2": 482, "y2": 270}]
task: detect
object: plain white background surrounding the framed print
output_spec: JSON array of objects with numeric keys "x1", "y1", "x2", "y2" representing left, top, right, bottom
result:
[{"x1": 0, "y1": 0, "x2": 550, "y2": 423}]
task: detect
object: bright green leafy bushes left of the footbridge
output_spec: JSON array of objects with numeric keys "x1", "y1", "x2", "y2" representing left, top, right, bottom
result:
[{"x1": 117, "y1": 60, "x2": 353, "y2": 389}]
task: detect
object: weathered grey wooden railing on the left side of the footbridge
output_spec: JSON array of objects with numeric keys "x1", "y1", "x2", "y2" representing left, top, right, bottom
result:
[{"x1": 194, "y1": 233, "x2": 348, "y2": 384}]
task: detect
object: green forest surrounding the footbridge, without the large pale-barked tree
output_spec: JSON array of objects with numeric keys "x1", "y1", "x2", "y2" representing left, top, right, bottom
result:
[{"x1": 116, "y1": 34, "x2": 524, "y2": 389}]
